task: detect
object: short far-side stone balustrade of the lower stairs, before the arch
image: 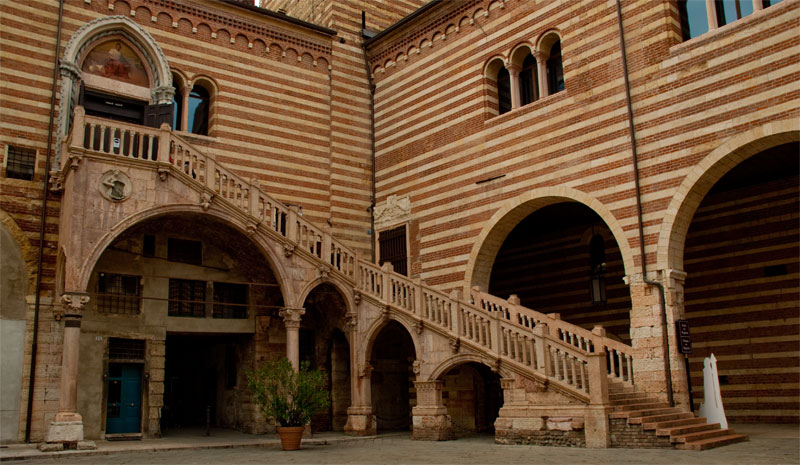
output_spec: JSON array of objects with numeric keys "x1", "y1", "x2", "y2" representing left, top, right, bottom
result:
[{"x1": 470, "y1": 289, "x2": 633, "y2": 385}]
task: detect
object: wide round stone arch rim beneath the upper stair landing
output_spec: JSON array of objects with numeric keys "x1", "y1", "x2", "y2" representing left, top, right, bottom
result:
[{"x1": 71, "y1": 204, "x2": 295, "y2": 302}]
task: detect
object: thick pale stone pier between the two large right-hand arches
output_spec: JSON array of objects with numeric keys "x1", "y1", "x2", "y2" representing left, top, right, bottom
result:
[{"x1": 625, "y1": 270, "x2": 689, "y2": 411}]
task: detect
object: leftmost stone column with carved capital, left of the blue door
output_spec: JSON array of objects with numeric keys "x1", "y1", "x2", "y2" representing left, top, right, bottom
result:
[{"x1": 46, "y1": 292, "x2": 94, "y2": 449}]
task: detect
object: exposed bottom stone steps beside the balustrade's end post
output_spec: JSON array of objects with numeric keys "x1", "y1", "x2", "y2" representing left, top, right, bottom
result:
[{"x1": 609, "y1": 383, "x2": 748, "y2": 450}]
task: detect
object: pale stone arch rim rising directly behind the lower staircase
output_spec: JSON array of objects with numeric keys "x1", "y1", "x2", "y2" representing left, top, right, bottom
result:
[{"x1": 464, "y1": 186, "x2": 634, "y2": 294}]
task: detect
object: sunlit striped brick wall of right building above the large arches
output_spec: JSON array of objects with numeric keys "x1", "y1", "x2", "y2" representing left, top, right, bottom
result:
[{"x1": 370, "y1": 0, "x2": 800, "y2": 421}]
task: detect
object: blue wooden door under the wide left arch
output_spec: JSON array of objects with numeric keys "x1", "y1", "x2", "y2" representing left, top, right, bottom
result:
[{"x1": 106, "y1": 363, "x2": 142, "y2": 434}]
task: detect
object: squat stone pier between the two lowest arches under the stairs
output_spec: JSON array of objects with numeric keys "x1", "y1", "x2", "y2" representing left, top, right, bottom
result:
[{"x1": 411, "y1": 380, "x2": 453, "y2": 441}]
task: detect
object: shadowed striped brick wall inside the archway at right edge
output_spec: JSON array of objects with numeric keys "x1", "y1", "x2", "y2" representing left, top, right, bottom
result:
[{"x1": 685, "y1": 144, "x2": 800, "y2": 423}]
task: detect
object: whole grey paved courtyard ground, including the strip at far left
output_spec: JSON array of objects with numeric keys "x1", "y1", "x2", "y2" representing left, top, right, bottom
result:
[{"x1": 0, "y1": 425, "x2": 800, "y2": 465}]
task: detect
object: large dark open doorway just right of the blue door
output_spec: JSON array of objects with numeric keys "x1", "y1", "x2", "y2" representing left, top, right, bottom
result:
[{"x1": 162, "y1": 335, "x2": 250, "y2": 435}]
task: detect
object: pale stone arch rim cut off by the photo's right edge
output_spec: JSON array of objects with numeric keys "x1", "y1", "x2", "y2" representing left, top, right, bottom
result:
[{"x1": 656, "y1": 120, "x2": 800, "y2": 270}]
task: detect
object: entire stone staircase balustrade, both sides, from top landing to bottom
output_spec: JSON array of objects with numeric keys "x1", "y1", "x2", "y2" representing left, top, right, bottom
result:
[{"x1": 67, "y1": 107, "x2": 633, "y2": 401}]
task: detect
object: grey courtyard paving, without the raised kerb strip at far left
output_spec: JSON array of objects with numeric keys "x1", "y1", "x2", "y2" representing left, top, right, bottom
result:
[{"x1": 12, "y1": 426, "x2": 800, "y2": 465}]
